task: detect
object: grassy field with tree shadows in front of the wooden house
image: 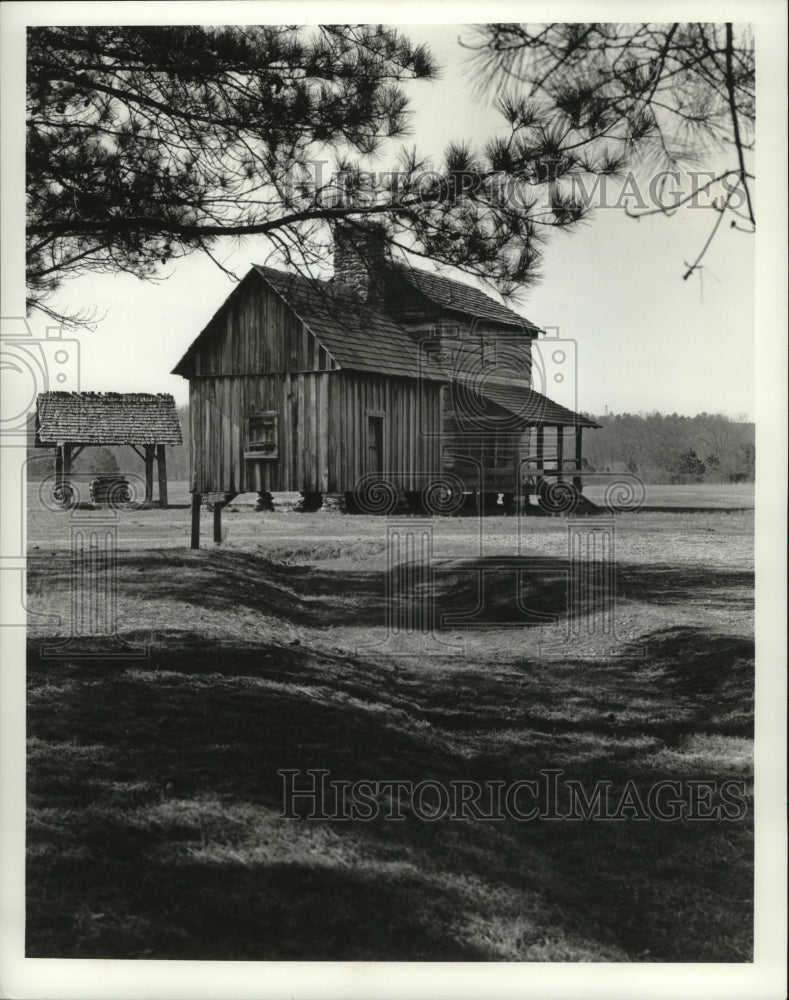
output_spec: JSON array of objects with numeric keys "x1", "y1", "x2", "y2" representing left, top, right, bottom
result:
[{"x1": 26, "y1": 484, "x2": 753, "y2": 962}]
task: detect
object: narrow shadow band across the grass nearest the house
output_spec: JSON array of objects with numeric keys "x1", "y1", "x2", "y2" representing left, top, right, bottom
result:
[{"x1": 28, "y1": 550, "x2": 754, "y2": 629}]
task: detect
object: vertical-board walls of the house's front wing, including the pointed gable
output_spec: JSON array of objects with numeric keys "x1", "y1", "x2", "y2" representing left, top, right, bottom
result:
[{"x1": 189, "y1": 276, "x2": 442, "y2": 493}]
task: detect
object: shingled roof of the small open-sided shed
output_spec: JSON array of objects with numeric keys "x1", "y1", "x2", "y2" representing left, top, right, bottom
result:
[{"x1": 36, "y1": 392, "x2": 181, "y2": 445}]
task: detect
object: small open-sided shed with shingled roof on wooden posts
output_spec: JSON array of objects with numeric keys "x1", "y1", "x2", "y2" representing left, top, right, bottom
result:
[{"x1": 36, "y1": 392, "x2": 183, "y2": 507}]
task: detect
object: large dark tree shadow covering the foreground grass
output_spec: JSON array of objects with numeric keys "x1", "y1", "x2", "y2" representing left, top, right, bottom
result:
[{"x1": 27, "y1": 624, "x2": 753, "y2": 961}]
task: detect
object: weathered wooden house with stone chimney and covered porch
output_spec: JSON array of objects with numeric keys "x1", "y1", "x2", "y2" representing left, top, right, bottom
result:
[{"x1": 174, "y1": 225, "x2": 597, "y2": 544}]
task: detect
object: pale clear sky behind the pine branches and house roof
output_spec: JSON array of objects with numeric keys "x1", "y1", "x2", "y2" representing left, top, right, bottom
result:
[{"x1": 6, "y1": 24, "x2": 755, "y2": 419}]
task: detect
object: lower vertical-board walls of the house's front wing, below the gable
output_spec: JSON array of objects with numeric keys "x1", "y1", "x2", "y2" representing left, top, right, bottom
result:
[{"x1": 189, "y1": 371, "x2": 441, "y2": 493}]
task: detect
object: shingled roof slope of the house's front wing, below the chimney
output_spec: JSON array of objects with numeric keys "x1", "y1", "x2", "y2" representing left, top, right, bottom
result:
[{"x1": 255, "y1": 264, "x2": 444, "y2": 381}]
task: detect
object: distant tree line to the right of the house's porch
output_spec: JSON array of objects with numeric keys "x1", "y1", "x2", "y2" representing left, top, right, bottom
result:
[{"x1": 584, "y1": 412, "x2": 756, "y2": 483}]
